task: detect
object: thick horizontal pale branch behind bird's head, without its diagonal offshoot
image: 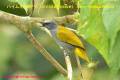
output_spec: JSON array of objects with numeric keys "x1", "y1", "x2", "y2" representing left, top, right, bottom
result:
[{"x1": 0, "y1": 10, "x2": 76, "y2": 32}]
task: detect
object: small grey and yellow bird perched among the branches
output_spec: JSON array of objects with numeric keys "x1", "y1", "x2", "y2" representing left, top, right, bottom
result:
[{"x1": 42, "y1": 20, "x2": 90, "y2": 63}]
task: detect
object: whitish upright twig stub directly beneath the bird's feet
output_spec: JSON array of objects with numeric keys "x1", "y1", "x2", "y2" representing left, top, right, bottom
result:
[{"x1": 64, "y1": 50, "x2": 72, "y2": 80}]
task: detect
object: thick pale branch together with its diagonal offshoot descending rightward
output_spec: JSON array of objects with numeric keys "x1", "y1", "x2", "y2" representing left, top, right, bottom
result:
[{"x1": 0, "y1": 11, "x2": 73, "y2": 76}]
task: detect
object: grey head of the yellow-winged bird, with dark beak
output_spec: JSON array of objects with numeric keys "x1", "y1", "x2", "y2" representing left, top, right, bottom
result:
[{"x1": 43, "y1": 20, "x2": 58, "y2": 30}]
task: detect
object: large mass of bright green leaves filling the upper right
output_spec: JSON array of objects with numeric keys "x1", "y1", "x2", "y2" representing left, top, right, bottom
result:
[{"x1": 78, "y1": 0, "x2": 120, "y2": 73}]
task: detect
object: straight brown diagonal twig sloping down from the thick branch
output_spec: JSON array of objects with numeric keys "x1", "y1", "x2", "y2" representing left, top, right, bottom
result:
[{"x1": 25, "y1": 32, "x2": 67, "y2": 76}]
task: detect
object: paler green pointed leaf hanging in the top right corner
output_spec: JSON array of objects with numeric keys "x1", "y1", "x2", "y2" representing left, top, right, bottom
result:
[{"x1": 103, "y1": 3, "x2": 120, "y2": 48}]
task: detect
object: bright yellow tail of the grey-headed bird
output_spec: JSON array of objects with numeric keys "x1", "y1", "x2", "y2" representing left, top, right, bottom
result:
[{"x1": 74, "y1": 48, "x2": 90, "y2": 63}]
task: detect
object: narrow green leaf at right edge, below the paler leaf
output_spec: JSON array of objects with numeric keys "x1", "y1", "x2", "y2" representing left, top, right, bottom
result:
[{"x1": 109, "y1": 31, "x2": 120, "y2": 73}]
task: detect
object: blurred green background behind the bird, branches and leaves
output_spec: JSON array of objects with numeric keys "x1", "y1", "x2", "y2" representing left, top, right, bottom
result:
[{"x1": 0, "y1": 0, "x2": 120, "y2": 80}]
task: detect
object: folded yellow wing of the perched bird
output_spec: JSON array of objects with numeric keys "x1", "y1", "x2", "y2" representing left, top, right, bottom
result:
[{"x1": 57, "y1": 26, "x2": 85, "y2": 49}]
